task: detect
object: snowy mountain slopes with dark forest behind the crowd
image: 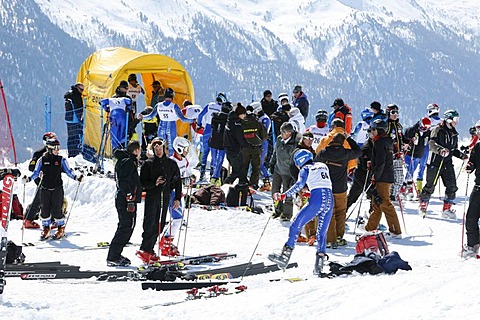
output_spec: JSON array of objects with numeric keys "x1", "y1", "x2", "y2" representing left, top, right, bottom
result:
[{"x1": 0, "y1": 0, "x2": 480, "y2": 160}]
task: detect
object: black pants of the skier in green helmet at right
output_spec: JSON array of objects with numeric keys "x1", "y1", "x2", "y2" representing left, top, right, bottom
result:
[{"x1": 420, "y1": 161, "x2": 458, "y2": 201}]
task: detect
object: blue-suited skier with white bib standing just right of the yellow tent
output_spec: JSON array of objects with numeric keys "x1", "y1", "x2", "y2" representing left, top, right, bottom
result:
[{"x1": 197, "y1": 92, "x2": 227, "y2": 180}]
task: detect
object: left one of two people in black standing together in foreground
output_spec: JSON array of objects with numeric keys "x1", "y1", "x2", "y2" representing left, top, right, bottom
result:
[{"x1": 107, "y1": 140, "x2": 142, "y2": 267}]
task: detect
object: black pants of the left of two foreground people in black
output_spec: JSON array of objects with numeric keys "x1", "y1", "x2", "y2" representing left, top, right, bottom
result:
[{"x1": 107, "y1": 195, "x2": 137, "y2": 261}]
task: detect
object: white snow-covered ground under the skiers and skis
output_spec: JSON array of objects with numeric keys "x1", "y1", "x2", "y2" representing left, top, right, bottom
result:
[{"x1": 0, "y1": 154, "x2": 480, "y2": 319}]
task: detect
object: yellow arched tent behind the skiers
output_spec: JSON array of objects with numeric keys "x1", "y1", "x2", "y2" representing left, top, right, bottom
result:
[{"x1": 77, "y1": 47, "x2": 194, "y2": 159}]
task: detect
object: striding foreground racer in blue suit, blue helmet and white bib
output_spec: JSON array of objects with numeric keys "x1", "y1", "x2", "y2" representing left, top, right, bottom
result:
[{"x1": 268, "y1": 149, "x2": 333, "y2": 276}]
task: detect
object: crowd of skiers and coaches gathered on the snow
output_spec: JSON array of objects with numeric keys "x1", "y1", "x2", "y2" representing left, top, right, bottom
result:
[{"x1": 16, "y1": 74, "x2": 480, "y2": 273}]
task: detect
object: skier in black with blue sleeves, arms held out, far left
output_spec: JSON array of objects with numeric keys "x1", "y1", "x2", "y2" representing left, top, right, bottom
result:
[{"x1": 23, "y1": 138, "x2": 83, "y2": 240}]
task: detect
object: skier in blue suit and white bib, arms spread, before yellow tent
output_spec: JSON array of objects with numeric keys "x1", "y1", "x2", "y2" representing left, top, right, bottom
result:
[{"x1": 137, "y1": 88, "x2": 195, "y2": 155}]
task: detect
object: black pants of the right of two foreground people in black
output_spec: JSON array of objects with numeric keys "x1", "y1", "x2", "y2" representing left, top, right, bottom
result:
[{"x1": 140, "y1": 191, "x2": 170, "y2": 254}]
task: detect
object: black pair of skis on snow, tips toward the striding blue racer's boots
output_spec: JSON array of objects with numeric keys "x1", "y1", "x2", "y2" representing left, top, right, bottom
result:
[{"x1": 142, "y1": 263, "x2": 298, "y2": 291}]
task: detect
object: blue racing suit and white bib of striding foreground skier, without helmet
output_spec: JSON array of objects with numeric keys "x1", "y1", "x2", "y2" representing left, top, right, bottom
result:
[{"x1": 285, "y1": 162, "x2": 333, "y2": 253}]
